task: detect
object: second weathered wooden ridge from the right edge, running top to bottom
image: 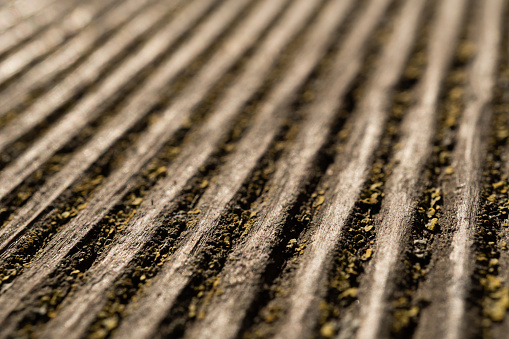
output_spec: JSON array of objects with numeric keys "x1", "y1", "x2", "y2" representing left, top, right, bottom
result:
[{"x1": 358, "y1": 1, "x2": 466, "y2": 338}]
